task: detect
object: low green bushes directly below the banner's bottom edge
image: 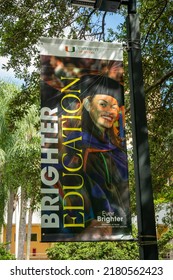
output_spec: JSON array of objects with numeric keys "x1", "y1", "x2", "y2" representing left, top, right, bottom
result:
[{"x1": 47, "y1": 242, "x2": 138, "y2": 260}]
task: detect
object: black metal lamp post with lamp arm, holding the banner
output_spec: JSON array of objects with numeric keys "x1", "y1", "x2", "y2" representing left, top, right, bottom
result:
[{"x1": 71, "y1": 0, "x2": 158, "y2": 260}]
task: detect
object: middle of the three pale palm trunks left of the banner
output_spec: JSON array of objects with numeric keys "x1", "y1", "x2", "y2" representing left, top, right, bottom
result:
[{"x1": 17, "y1": 188, "x2": 27, "y2": 260}]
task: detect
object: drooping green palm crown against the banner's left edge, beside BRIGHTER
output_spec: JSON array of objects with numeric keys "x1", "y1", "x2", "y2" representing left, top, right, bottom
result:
[{"x1": 6, "y1": 104, "x2": 40, "y2": 201}]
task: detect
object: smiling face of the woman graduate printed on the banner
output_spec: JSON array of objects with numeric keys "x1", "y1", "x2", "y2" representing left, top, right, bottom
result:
[{"x1": 88, "y1": 94, "x2": 119, "y2": 132}]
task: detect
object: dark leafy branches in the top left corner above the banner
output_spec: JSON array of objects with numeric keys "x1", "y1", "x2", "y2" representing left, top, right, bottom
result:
[{"x1": 0, "y1": 0, "x2": 74, "y2": 76}]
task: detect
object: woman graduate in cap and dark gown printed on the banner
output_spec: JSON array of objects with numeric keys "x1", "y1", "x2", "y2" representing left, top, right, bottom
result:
[{"x1": 60, "y1": 75, "x2": 131, "y2": 240}]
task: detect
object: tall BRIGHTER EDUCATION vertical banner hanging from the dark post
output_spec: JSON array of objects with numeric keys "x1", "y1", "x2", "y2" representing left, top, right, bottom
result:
[{"x1": 40, "y1": 38, "x2": 131, "y2": 242}]
